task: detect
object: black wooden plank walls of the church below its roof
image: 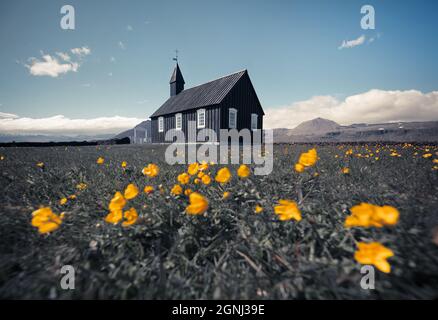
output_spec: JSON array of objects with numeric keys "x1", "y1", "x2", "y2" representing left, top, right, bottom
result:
[{"x1": 151, "y1": 74, "x2": 264, "y2": 143}]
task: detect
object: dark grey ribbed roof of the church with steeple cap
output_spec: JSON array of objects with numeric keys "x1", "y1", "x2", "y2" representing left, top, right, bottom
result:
[{"x1": 151, "y1": 69, "x2": 247, "y2": 118}]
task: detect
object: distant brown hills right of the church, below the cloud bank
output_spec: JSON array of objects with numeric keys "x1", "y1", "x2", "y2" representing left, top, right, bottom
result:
[{"x1": 274, "y1": 118, "x2": 438, "y2": 142}]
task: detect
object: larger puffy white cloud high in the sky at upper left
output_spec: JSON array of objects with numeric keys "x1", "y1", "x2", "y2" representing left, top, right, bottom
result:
[{"x1": 25, "y1": 54, "x2": 79, "y2": 78}]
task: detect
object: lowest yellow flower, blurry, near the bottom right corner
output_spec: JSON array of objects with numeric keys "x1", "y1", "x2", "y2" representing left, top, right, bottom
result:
[{"x1": 354, "y1": 242, "x2": 394, "y2": 273}]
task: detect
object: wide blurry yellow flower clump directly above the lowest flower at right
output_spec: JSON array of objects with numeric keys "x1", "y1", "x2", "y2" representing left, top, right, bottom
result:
[{"x1": 345, "y1": 203, "x2": 400, "y2": 228}]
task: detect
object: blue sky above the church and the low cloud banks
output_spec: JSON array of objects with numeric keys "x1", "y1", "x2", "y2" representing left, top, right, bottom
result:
[{"x1": 0, "y1": 0, "x2": 438, "y2": 131}]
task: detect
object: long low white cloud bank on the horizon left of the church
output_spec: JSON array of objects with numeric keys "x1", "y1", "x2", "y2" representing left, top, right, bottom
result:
[{"x1": 0, "y1": 113, "x2": 144, "y2": 135}]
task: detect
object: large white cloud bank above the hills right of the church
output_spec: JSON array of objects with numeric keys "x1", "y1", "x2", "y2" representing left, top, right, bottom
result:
[{"x1": 263, "y1": 89, "x2": 438, "y2": 128}]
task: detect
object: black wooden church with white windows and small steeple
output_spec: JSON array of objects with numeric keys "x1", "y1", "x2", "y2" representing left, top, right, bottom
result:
[{"x1": 150, "y1": 63, "x2": 265, "y2": 143}]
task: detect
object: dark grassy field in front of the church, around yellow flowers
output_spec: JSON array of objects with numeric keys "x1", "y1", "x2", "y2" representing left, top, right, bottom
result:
[{"x1": 0, "y1": 144, "x2": 438, "y2": 299}]
